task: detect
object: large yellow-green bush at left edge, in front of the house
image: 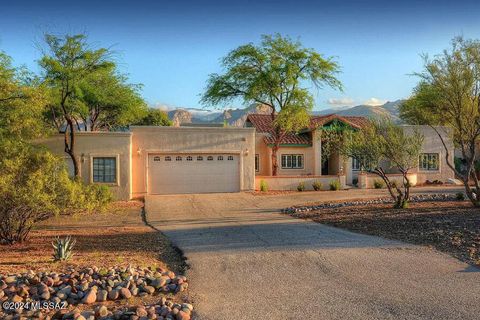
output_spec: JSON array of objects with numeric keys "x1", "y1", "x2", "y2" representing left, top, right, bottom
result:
[{"x1": 0, "y1": 139, "x2": 111, "y2": 244}]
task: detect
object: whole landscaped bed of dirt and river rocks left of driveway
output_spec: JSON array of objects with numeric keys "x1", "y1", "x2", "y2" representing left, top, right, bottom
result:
[{"x1": 0, "y1": 202, "x2": 193, "y2": 320}]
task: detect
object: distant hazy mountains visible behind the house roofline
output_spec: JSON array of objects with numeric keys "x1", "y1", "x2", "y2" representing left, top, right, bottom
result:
[{"x1": 164, "y1": 100, "x2": 405, "y2": 127}]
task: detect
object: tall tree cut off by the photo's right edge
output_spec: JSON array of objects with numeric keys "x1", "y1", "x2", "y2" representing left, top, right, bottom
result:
[{"x1": 400, "y1": 37, "x2": 480, "y2": 207}]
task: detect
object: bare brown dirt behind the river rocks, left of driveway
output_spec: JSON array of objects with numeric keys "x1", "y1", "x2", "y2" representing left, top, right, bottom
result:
[{"x1": 0, "y1": 202, "x2": 185, "y2": 274}]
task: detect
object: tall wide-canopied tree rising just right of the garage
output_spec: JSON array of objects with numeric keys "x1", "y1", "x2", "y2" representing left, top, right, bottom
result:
[{"x1": 202, "y1": 34, "x2": 341, "y2": 175}]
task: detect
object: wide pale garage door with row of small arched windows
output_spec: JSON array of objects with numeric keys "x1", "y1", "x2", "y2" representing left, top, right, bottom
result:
[{"x1": 148, "y1": 154, "x2": 240, "y2": 194}]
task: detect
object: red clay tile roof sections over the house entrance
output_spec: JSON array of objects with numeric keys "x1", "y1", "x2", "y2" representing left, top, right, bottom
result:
[{"x1": 247, "y1": 114, "x2": 368, "y2": 145}]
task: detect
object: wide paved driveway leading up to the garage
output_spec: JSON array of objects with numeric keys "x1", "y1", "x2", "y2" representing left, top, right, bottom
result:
[{"x1": 146, "y1": 192, "x2": 480, "y2": 320}]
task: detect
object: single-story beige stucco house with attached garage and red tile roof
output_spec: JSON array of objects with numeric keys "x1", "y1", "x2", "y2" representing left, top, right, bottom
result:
[{"x1": 41, "y1": 114, "x2": 453, "y2": 200}]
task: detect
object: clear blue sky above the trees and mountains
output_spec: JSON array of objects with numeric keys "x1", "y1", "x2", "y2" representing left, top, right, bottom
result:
[{"x1": 0, "y1": 0, "x2": 480, "y2": 109}]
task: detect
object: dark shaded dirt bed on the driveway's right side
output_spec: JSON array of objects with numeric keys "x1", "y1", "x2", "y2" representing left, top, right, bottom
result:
[{"x1": 293, "y1": 201, "x2": 480, "y2": 266}]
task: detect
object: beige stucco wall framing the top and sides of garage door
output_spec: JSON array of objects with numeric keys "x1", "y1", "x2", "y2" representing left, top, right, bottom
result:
[{"x1": 130, "y1": 126, "x2": 255, "y2": 197}]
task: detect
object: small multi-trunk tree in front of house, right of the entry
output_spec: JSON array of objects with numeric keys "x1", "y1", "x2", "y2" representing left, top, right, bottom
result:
[{"x1": 341, "y1": 119, "x2": 424, "y2": 208}]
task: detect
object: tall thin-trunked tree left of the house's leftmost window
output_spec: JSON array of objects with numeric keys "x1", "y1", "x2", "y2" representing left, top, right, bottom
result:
[{"x1": 39, "y1": 34, "x2": 113, "y2": 177}]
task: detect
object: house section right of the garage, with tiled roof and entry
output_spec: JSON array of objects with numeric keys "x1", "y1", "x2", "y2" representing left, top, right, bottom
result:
[{"x1": 246, "y1": 114, "x2": 454, "y2": 189}]
